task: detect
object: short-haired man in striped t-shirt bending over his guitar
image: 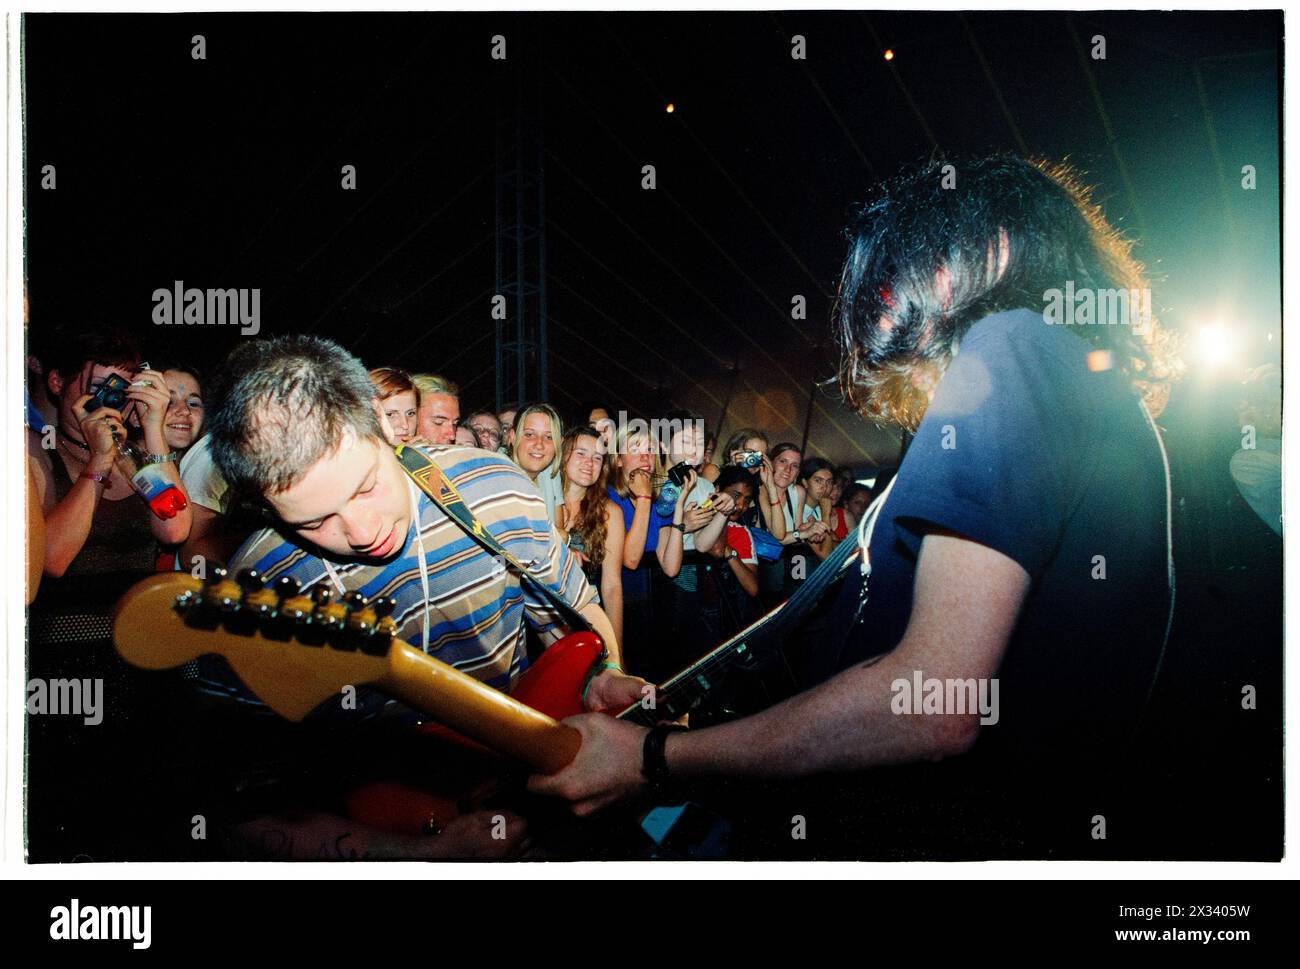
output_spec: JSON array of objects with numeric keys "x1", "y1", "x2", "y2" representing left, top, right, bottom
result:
[{"x1": 200, "y1": 337, "x2": 646, "y2": 857}]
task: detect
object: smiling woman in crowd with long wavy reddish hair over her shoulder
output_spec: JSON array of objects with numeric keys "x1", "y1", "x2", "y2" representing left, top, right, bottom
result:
[{"x1": 555, "y1": 427, "x2": 623, "y2": 643}]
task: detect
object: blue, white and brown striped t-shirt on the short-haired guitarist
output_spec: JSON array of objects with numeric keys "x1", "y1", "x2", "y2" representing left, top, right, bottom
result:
[{"x1": 204, "y1": 445, "x2": 595, "y2": 712}]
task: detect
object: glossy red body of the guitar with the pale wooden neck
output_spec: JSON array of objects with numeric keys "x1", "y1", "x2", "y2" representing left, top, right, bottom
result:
[{"x1": 347, "y1": 632, "x2": 605, "y2": 835}]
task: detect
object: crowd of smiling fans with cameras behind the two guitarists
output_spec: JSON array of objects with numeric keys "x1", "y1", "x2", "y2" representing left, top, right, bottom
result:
[{"x1": 29, "y1": 330, "x2": 870, "y2": 679}]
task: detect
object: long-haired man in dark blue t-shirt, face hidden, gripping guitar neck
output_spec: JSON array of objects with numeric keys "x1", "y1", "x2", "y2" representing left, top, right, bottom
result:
[{"x1": 530, "y1": 157, "x2": 1173, "y2": 857}]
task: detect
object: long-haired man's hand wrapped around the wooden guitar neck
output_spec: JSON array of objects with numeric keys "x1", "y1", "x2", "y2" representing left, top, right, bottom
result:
[{"x1": 528, "y1": 713, "x2": 649, "y2": 817}]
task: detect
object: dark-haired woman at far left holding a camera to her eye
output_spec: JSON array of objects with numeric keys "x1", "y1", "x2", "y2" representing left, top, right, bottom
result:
[{"x1": 26, "y1": 328, "x2": 191, "y2": 862}]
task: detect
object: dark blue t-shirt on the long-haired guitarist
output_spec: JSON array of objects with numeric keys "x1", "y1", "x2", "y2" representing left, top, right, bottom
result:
[{"x1": 833, "y1": 310, "x2": 1170, "y2": 762}]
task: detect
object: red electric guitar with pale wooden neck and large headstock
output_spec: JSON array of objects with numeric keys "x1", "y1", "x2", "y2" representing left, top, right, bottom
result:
[{"x1": 112, "y1": 568, "x2": 780, "y2": 834}]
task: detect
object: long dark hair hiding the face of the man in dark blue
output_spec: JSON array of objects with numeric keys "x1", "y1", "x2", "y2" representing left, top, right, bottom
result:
[{"x1": 833, "y1": 155, "x2": 1178, "y2": 429}]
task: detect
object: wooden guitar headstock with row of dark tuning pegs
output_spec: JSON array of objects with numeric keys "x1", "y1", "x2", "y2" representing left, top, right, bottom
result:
[{"x1": 113, "y1": 568, "x2": 397, "y2": 721}]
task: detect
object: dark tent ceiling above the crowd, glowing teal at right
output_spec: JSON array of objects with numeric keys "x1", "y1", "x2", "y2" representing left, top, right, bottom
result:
[{"x1": 25, "y1": 12, "x2": 1282, "y2": 464}]
